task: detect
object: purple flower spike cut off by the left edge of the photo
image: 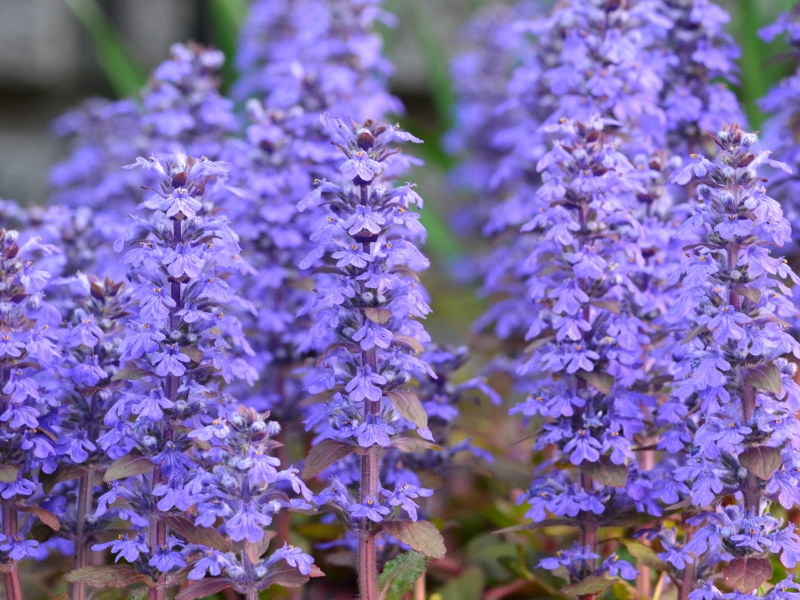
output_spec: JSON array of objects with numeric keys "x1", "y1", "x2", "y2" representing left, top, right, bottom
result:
[{"x1": 0, "y1": 230, "x2": 61, "y2": 600}]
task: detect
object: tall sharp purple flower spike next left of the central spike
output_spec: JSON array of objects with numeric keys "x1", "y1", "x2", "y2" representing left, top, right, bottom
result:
[{"x1": 95, "y1": 155, "x2": 254, "y2": 598}]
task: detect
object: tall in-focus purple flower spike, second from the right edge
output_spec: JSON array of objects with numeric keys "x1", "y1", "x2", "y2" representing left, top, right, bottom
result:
[{"x1": 512, "y1": 117, "x2": 660, "y2": 582}]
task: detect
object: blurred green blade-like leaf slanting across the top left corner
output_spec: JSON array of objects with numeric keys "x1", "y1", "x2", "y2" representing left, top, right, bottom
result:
[{"x1": 64, "y1": 0, "x2": 146, "y2": 97}]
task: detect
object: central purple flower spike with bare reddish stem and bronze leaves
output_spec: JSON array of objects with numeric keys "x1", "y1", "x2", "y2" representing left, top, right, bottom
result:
[{"x1": 300, "y1": 113, "x2": 444, "y2": 600}]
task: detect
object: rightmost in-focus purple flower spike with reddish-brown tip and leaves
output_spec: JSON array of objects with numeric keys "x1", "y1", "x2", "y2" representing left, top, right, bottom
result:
[{"x1": 660, "y1": 124, "x2": 800, "y2": 598}]
